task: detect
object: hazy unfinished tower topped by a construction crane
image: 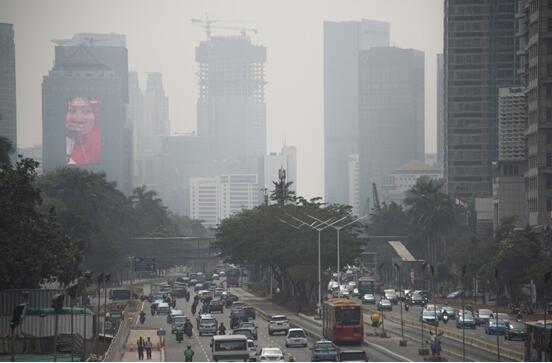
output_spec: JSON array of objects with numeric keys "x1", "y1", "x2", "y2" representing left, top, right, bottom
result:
[{"x1": 196, "y1": 35, "x2": 266, "y2": 173}]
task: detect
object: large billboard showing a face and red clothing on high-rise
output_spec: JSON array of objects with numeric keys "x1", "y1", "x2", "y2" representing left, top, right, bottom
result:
[{"x1": 65, "y1": 97, "x2": 101, "y2": 164}]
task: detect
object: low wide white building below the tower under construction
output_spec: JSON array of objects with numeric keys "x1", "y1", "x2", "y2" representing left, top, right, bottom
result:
[{"x1": 190, "y1": 174, "x2": 259, "y2": 228}]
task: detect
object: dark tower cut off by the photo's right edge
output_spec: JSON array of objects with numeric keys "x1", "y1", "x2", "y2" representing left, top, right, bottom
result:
[{"x1": 525, "y1": 0, "x2": 552, "y2": 225}]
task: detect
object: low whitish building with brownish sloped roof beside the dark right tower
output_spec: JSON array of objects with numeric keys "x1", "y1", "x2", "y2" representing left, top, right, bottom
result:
[{"x1": 382, "y1": 160, "x2": 443, "y2": 205}]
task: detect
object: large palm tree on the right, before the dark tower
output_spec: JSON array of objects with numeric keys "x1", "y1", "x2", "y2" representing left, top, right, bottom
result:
[{"x1": 404, "y1": 177, "x2": 455, "y2": 264}]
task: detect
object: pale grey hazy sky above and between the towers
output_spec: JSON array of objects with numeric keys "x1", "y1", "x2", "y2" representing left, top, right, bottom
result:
[{"x1": 0, "y1": 0, "x2": 443, "y2": 197}]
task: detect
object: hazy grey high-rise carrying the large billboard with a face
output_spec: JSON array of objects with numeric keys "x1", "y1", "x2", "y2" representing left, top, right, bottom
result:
[{"x1": 42, "y1": 33, "x2": 133, "y2": 193}]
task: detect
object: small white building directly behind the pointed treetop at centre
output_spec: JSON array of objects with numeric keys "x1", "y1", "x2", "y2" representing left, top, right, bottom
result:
[{"x1": 258, "y1": 145, "x2": 297, "y2": 203}]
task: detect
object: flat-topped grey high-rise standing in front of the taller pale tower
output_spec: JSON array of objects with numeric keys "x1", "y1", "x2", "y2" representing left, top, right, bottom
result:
[{"x1": 357, "y1": 47, "x2": 425, "y2": 210}]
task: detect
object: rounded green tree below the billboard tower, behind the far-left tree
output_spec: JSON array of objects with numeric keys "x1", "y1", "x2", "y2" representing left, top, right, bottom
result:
[{"x1": 37, "y1": 167, "x2": 134, "y2": 272}]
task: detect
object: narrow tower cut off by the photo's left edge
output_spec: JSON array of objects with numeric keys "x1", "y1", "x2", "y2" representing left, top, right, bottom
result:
[{"x1": 0, "y1": 23, "x2": 17, "y2": 157}]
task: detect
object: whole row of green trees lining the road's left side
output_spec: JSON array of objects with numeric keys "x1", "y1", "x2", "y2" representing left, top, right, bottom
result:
[{"x1": 0, "y1": 139, "x2": 205, "y2": 289}]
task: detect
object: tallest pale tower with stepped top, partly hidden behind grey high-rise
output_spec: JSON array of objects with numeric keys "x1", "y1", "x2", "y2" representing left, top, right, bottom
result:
[{"x1": 324, "y1": 19, "x2": 389, "y2": 204}]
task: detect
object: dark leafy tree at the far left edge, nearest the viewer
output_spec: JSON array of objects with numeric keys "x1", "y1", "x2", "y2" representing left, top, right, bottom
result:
[{"x1": 0, "y1": 159, "x2": 83, "y2": 289}]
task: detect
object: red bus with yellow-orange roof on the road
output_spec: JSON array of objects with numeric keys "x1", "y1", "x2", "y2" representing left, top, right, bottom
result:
[{"x1": 322, "y1": 298, "x2": 364, "y2": 345}]
